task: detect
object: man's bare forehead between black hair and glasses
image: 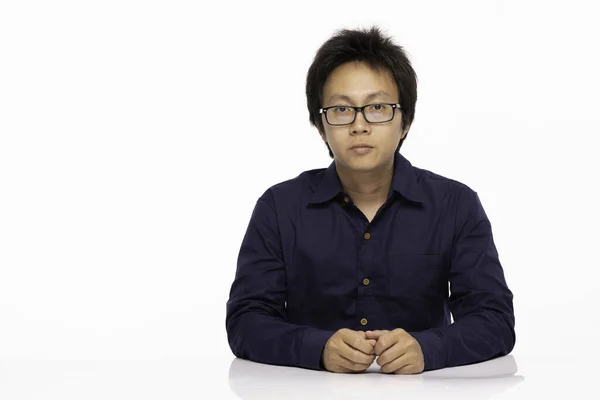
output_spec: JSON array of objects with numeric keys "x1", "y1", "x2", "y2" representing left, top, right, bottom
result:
[{"x1": 323, "y1": 62, "x2": 398, "y2": 103}]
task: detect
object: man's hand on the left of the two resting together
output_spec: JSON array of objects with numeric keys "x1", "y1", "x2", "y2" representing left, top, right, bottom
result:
[{"x1": 323, "y1": 328, "x2": 376, "y2": 373}]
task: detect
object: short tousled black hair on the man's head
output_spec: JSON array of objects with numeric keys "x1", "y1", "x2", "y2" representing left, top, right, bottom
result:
[{"x1": 306, "y1": 26, "x2": 417, "y2": 158}]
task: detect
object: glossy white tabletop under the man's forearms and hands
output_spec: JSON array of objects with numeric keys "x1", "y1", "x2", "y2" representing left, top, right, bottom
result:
[{"x1": 0, "y1": 350, "x2": 600, "y2": 400}]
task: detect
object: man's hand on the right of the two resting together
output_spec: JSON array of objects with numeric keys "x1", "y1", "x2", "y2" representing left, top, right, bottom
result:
[{"x1": 365, "y1": 329, "x2": 425, "y2": 374}]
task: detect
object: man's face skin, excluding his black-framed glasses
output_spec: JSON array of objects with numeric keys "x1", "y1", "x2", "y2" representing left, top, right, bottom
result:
[{"x1": 321, "y1": 62, "x2": 403, "y2": 171}]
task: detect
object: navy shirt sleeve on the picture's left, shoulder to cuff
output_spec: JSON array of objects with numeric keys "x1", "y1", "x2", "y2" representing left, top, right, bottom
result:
[{"x1": 225, "y1": 191, "x2": 335, "y2": 370}]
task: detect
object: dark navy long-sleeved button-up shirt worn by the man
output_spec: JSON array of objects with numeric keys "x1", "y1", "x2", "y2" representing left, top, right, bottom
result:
[{"x1": 226, "y1": 153, "x2": 515, "y2": 371}]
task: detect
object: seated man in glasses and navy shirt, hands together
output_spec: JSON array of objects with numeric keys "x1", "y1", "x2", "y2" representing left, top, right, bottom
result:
[{"x1": 226, "y1": 28, "x2": 515, "y2": 374}]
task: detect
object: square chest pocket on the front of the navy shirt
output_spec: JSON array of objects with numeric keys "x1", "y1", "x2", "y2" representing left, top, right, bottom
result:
[{"x1": 387, "y1": 254, "x2": 448, "y2": 297}]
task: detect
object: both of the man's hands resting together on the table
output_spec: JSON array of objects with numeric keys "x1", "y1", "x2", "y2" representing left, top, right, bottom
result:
[{"x1": 323, "y1": 328, "x2": 425, "y2": 374}]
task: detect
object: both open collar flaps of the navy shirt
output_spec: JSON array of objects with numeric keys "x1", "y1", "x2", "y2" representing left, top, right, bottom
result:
[{"x1": 309, "y1": 152, "x2": 424, "y2": 204}]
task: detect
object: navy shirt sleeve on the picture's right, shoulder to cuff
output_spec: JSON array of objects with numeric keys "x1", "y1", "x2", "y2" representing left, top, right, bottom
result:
[{"x1": 409, "y1": 188, "x2": 516, "y2": 371}]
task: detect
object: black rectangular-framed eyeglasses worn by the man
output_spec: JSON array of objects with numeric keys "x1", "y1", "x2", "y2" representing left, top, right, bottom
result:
[{"x1": 319, "y1": 103, "x2": 402, "y2": 126}]
